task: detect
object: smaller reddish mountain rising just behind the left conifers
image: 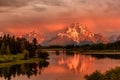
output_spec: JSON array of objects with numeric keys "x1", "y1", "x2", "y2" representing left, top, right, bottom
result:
[{"x1": 20, "y1": 31, "x2": 44, "y2": 43}]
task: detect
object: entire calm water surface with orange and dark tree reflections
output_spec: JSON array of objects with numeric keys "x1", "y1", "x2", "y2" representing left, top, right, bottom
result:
[{"x1": 0, "y1": 51, "x2": 120, "y2": 80}]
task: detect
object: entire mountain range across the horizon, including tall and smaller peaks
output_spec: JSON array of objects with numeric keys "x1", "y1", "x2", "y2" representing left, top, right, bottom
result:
[{"x1": 0, "y1": 23, "x2": 120, "y2": 46}]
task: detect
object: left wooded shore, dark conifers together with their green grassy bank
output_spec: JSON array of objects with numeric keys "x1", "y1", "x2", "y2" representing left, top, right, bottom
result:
[{"x1": 0, "y1": 34, "x2": 49, "y2": 63}]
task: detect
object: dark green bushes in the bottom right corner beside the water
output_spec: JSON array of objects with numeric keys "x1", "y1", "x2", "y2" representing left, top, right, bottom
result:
[{"x1": 85, "y1": 67, "x2": 120, "y2": 80}]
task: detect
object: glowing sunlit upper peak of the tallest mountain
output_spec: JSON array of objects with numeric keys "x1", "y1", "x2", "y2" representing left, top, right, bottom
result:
[{"x1": 58, "y1": 23, "x2": 94, "y2": 44}]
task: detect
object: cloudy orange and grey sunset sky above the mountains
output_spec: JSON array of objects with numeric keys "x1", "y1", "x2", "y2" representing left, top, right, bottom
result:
[{"x1": 0, "y1": 0, "x2": 120, "y2": 35}]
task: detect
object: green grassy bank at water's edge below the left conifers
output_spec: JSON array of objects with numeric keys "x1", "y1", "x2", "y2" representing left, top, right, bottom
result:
[{"x1": 0, "y1": 54, "x2": 41, "y2": 67}]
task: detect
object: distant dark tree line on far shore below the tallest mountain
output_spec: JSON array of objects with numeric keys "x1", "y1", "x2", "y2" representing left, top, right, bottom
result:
[{"x1": 43, "y1": 41, "x2": 120, "y2": 51}]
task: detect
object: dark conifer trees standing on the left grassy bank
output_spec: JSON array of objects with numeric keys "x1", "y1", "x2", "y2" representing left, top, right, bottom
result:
[{"x1": 0, "y1": 34, "x2": 48, "y2": 59}]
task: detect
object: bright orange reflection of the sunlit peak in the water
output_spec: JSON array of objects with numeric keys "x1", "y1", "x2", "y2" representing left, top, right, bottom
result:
[{"x1": 58, "y1": 54, "x2": 94, "y2": 72}]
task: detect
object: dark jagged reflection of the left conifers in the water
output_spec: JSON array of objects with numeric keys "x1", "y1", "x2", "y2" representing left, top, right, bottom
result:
[{"x1": 0, "y1": 61, "x2": 49, "y2": 80}]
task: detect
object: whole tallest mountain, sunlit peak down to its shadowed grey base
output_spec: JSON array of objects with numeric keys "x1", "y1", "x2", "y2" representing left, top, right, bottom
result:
[{"x1": 45, "y1": 23, "x2": 109, "y2": 45}]
